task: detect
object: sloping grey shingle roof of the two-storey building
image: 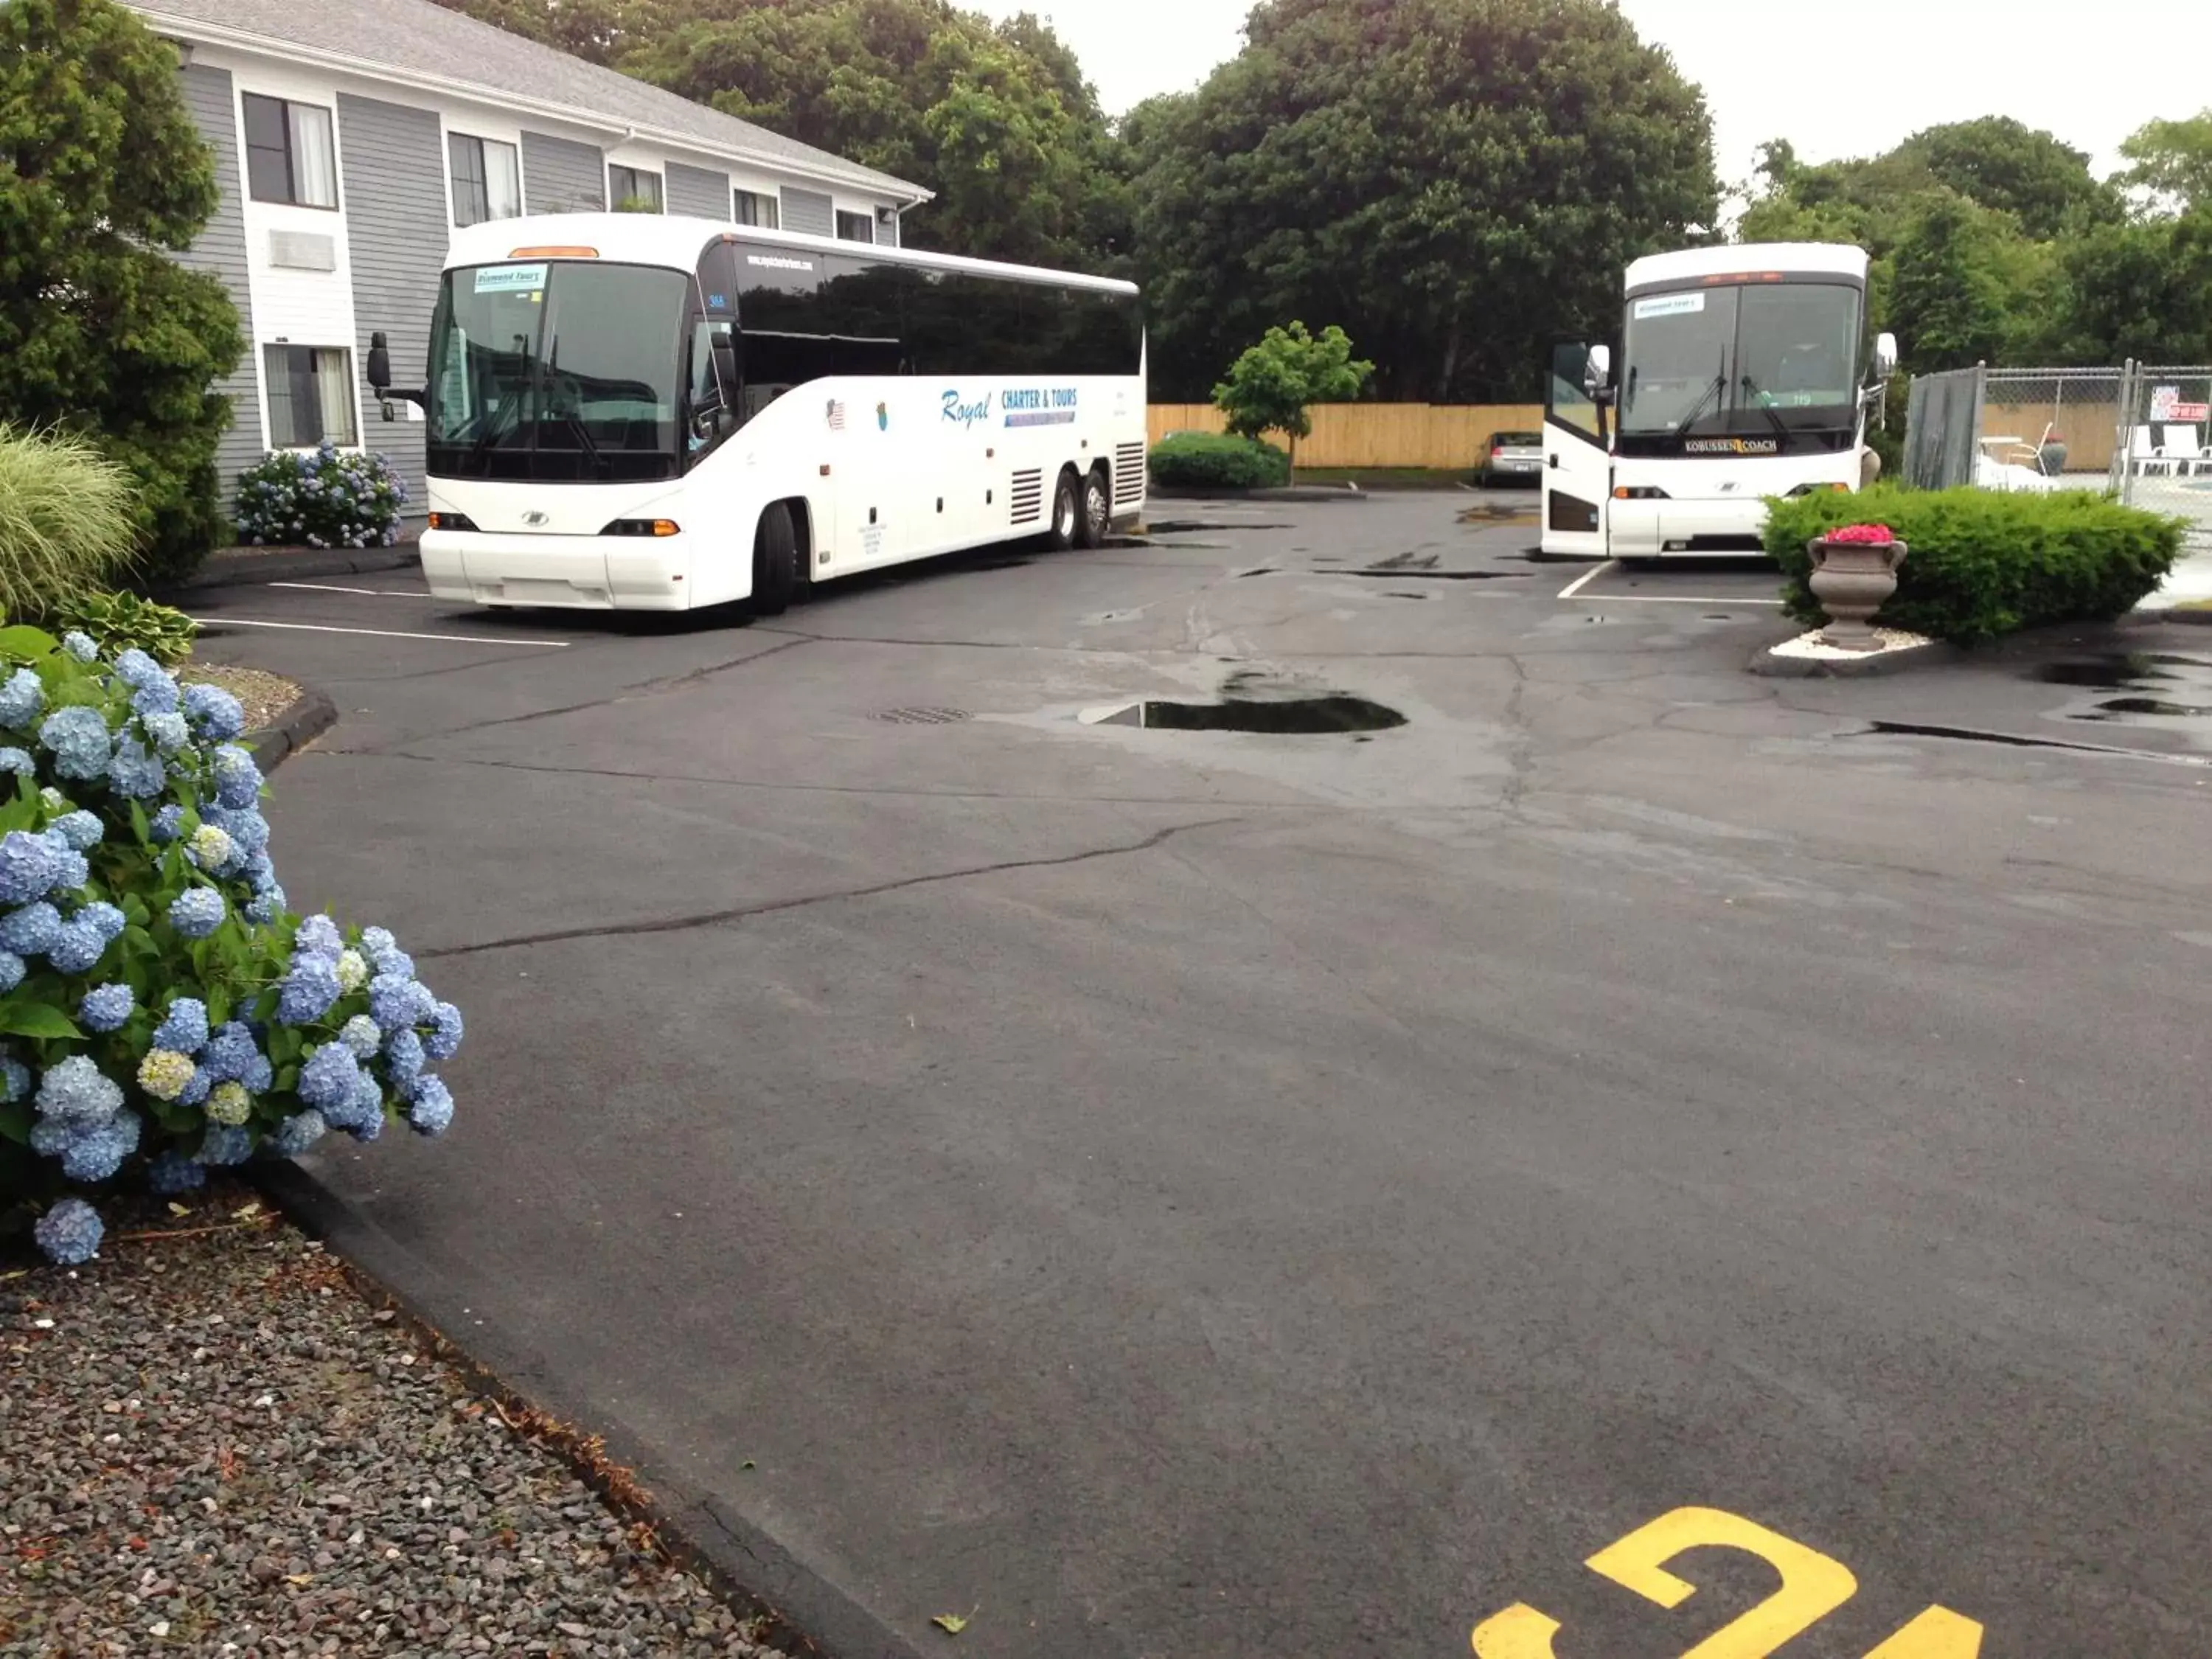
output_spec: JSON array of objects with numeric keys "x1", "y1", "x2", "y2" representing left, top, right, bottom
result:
[{"x1": 131, "y1": 0, "x2": 927, "y2": 197}]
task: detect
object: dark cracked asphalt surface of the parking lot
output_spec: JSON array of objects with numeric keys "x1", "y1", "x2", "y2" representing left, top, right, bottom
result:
[{"x1": 186, "y1": 507, "x2": 2212, "y2": 1659}]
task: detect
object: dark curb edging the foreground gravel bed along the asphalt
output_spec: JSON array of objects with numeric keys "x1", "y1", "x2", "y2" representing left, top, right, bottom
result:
[{"x1": 246, "y1": 1161, "x2": 925, "y2": 1659}]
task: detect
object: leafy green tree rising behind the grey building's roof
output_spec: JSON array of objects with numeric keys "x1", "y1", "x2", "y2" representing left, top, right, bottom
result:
[{"x1": 611, "y1": 0, "x2": 1128, "y2": 270}]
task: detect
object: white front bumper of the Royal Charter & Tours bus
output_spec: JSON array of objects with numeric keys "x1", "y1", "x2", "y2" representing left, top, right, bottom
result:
[{"x1": 422, "y1": 531, "x2": 690, "y2": 611}]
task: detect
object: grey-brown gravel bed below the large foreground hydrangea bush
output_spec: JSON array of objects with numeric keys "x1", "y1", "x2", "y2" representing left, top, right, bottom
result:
[{"x1": 0, "y1": 1186, "x2": 781, "y2": 1659}]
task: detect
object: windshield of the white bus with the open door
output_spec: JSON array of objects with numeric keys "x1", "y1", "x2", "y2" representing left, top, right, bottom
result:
[{"x1": 1619, "y1": 281, "x2": 1860, "y2": 438}]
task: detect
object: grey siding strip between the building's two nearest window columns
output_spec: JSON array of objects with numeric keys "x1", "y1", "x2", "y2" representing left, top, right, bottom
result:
[{"x1": 338, "y1": 93, "x2": 449, "y2": 515}]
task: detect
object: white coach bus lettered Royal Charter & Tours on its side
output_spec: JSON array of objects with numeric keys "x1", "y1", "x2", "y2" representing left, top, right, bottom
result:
[{"x1": 369, "y1": 212, "x2": 1146, "y2": 613}]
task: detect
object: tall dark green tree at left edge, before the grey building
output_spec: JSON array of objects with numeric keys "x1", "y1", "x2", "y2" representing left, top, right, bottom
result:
[{"x1": 0, "y1": 0, "x2": 241, "y2": 575}]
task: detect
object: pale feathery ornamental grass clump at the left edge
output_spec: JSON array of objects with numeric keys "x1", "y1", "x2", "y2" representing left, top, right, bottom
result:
[{"x1": 0, "y1": 427, "x2": 137, "y2": 617}]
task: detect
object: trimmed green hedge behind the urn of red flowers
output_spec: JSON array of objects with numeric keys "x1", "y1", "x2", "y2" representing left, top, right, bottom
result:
[{"x1": 1765, "y1": 484, "x2": 2181, "y2": 644}]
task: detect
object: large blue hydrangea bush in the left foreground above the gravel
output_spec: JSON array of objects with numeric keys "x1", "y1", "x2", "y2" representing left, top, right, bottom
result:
[{"x1": 0, "y1": 628, "x2": 462, "y2": 1263}]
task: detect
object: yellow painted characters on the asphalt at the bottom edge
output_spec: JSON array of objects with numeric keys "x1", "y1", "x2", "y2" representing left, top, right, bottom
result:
[{"x1": 1475, "y1": 1509, "x2": 1982, "y2": 1659}]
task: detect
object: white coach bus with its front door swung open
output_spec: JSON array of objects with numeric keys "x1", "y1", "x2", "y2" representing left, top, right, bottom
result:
[{"x1": 1542, "y1": 241, "x2": 1898, "y2": 560}]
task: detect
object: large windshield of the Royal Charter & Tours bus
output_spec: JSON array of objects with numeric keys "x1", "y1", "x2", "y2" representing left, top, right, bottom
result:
[{"x1": 427, "y1": 261, "x2": 690, "y2": 482}]
